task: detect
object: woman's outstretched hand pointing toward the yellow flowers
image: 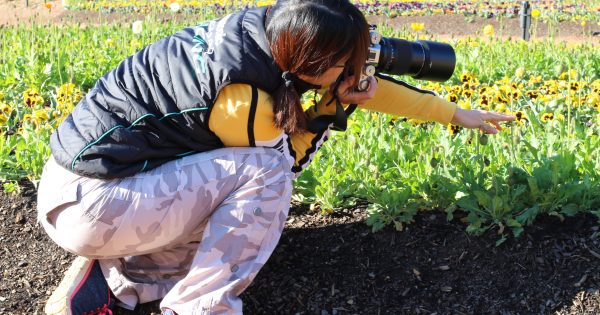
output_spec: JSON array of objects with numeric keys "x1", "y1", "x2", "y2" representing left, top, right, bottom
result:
[{"x1": 451, "y1": 107, "x2": 516, "y2": 134}]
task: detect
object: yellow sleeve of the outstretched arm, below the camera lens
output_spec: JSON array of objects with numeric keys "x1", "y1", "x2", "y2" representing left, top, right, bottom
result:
[{"x1": 359, "y1": 75, "x2": 456, "y2": 124}]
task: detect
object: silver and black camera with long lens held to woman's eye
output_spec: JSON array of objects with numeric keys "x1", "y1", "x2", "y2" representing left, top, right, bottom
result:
[{"x1": 357, "y1": 25, "x2": 456, "y2": 91}]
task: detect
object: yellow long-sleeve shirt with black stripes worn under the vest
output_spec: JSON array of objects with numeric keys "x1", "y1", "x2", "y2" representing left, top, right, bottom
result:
[{"x1": 209, "y1": 76, "x2": 456, "y2": 175}]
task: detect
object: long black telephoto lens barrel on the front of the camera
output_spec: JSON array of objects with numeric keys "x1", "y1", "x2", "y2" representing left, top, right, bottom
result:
[{"x1": 376, "y1": 37, "x2": 456, "y2": 82}]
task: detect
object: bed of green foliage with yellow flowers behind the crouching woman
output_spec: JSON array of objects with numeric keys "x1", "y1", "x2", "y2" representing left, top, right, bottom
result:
[{"x1": 0, "y1": 9, "x2": 600, "y2": 244}]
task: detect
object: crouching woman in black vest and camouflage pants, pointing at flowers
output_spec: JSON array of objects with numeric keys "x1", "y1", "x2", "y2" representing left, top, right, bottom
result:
[{"x1": 38, "y1": 0, "x2": 513, "y2": 314}]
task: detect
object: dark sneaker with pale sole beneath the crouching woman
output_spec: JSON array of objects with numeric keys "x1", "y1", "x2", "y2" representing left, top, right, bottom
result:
[{"x1": 44, "y1": 257, "x2": 115, "y2": 315}]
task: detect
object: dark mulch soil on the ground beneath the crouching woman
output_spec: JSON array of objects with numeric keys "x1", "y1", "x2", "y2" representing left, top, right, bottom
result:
[{"x1": 0, "y1": 185, "x2": 600, "y2": 314}]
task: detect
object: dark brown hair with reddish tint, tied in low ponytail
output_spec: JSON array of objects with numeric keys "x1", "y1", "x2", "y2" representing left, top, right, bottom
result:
[{"x1": 266, "y1": 0, "x2": 370, "y2": 134}]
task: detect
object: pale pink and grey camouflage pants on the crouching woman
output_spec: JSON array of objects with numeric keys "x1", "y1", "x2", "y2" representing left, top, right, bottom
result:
[{"x1": 38, "y1": 148, "x2": 292, "y2": 314}]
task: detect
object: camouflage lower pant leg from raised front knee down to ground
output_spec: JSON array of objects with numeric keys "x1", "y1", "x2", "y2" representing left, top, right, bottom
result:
[{"x1": 161, "y1": 155, "x2": 292, "y2": 314}]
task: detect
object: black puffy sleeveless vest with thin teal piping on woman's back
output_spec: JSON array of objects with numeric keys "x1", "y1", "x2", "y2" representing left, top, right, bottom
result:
[{"x1": 50, "y1": 8, "x2": 282, "y2": 178}]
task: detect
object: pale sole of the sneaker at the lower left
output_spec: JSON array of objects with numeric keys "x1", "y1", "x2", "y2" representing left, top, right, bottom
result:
[{"x1": 44, "y1": 256, "x2": 95, "y2": 315}]
